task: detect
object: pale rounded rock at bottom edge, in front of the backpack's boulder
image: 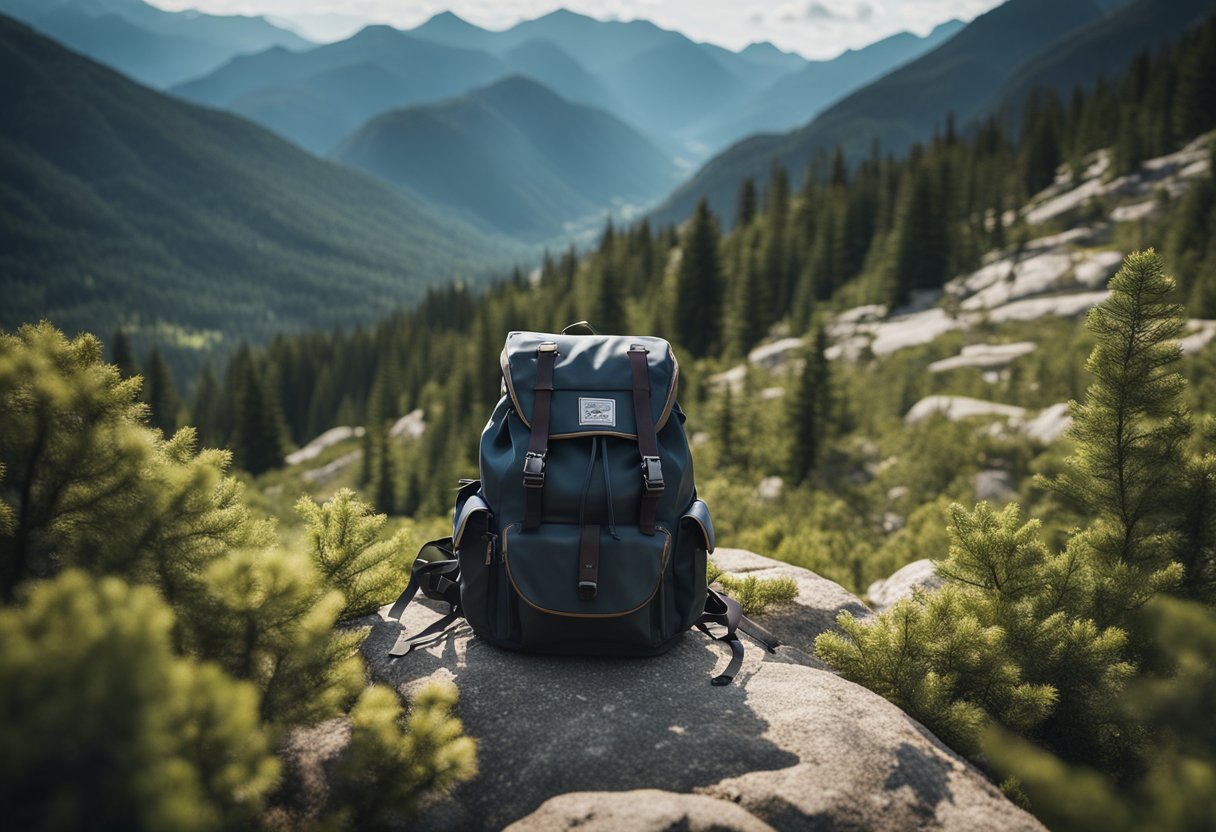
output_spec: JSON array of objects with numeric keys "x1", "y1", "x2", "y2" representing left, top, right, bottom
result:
[{"x1": 507, "y1": 788, "x2": 772, "y2": 832}]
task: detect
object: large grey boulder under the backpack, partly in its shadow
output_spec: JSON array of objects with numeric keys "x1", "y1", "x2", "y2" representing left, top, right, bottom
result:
[{"x1": 364, "y1": 550, "x2": 1042, "y2": 831}]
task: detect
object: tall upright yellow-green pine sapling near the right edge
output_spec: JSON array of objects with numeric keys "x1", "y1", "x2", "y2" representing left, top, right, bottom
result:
[{"x1": 1051, "y1": 249, "x2": 1190, "y2": 624}]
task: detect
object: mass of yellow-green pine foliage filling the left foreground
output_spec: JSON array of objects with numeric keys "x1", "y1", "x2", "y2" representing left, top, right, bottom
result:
[{"x1": 0, "y1": 324, "x2": 473, "y2": 830}]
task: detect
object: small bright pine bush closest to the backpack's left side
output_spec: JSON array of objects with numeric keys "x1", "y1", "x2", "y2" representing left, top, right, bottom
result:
[{"x1": 295, "y1": 488, "x2": 410, "y2": 620}]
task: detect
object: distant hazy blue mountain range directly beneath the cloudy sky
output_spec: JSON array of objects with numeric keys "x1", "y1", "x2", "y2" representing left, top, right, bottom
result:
[{"x1": 174, "y1": 10, "x2": 950, "y2": 163}]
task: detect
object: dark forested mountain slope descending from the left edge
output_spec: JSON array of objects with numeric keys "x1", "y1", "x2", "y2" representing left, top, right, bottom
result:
[{"x1": 0, "y1": 18, "x2": 518, "y2": 377}]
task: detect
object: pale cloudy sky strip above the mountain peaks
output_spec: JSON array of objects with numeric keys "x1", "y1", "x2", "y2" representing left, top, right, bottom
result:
[{"x1": 148, "y1": 0, "x2": 1001, "y2": 58}]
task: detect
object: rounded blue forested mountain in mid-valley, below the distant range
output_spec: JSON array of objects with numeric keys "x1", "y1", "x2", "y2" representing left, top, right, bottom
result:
[{"x1": 334, "y1": 75, "x2": 677, "y2": 240}]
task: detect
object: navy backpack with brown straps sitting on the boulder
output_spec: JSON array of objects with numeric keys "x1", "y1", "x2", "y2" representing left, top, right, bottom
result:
[{"x1": 389, "y1": 322, "x2": 777, "y2": 685}]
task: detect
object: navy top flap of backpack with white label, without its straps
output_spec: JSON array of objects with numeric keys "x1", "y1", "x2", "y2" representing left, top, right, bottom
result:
[{"x1": 501, "y1": 332, "x2": 680, "y2": 439}]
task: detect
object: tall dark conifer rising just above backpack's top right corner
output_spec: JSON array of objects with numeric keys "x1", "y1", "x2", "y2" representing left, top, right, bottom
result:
[{"x1": 675, "y1": 199, "x2": 722, "y2": 356}]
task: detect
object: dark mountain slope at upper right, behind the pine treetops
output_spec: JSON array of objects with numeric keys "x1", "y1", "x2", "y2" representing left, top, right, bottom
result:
[{"x1": 652, "y1": 0, "x2": 1216, "y2": 223}]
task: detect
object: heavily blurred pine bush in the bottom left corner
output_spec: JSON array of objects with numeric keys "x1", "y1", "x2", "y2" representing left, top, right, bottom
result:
[{"x1": 0, "y1": 569, "x2": 278, "y2": 830}]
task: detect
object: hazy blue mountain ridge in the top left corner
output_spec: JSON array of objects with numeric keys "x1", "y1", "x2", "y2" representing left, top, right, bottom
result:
[{"x1": 0, "y1": 0, "x2": 313, "y2": 88}]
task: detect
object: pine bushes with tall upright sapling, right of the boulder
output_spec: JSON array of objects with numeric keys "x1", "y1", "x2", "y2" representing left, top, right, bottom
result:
[{"x1": 816, "y1": 249, "x2": 1216, "y2": 783}]
